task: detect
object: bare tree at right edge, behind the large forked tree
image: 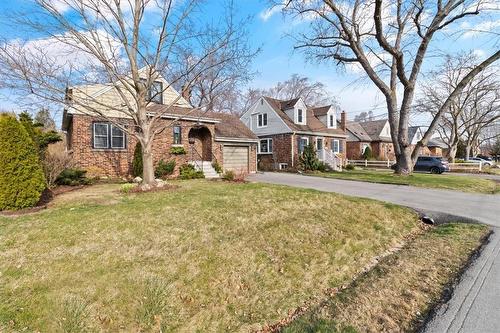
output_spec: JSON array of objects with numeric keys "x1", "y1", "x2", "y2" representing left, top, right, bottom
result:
[{"x1": 415, "y1": 54, "x2": 500, "y2": 160}]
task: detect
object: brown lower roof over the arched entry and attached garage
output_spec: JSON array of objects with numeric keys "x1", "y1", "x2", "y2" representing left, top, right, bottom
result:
[{"x1": 148, "y1": 104, "x2": 257, "y2": 140}]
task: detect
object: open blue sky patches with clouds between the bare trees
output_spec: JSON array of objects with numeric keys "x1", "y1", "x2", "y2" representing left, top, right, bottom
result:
[{"x1": 0, "y1": 0, "x2": 500, "y2": 123}]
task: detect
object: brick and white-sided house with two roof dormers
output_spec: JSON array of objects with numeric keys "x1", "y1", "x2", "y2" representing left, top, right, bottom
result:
[{"x1": 240, "y1": 96, "x2": 347, "y2": 170}]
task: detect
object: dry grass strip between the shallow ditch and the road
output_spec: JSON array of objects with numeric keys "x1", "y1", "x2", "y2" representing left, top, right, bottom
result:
[{"x1": 282, "y1": 224, "x2": 490, "y2": 333}]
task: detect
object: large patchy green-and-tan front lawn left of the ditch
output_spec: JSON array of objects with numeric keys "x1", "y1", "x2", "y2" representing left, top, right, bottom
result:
[{"x1": 0, "y1": 180, "x2": 418, "y2": 332}]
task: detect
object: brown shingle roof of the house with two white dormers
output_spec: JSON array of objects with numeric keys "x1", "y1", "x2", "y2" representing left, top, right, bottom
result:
[{"x1": 264, "y1": 96, "x2": 345, "y2": 135}]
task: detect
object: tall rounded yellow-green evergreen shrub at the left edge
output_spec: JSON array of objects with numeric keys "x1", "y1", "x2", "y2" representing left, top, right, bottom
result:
[{"x1": 0, "y1": 114, "x2": 45, "y2": 210}]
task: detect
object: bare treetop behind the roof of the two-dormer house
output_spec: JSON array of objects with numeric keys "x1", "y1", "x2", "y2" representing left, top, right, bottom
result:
[{"x1": 241, "y1": 74, "x2": 337, "y2": 111}]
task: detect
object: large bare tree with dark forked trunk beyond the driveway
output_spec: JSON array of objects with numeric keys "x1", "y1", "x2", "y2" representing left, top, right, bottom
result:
[{"x1": 284, "y1": 0, "x2": 500, "y2": 174}]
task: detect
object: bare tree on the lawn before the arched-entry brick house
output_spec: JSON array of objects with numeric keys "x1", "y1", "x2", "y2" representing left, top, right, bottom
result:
[{"x1": 0, "y1": 0, "x2": 250, "y2": 184}]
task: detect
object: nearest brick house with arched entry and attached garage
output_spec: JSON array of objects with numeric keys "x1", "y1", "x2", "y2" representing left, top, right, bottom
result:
[{"x1": 62, "y1": 69, "x2": 258, "y2": 177}]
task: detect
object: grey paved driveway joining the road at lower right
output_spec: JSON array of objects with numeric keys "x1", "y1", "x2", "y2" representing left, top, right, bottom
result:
[{"x1": 249, "y1": 173, "x2": 500, "y2": 333}]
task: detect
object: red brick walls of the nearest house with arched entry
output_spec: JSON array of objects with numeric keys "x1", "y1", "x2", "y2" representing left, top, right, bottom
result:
[{"x1": 67, "y1": 115, "x2": 257, "y2": 178}]
